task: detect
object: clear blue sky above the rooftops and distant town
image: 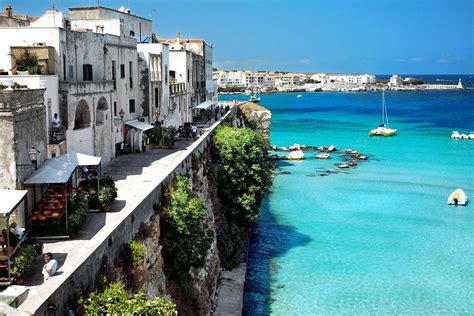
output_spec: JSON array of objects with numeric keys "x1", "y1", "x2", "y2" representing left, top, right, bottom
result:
[{"x1": 0, "y1": 0, "x2": 474, "y2": 74}]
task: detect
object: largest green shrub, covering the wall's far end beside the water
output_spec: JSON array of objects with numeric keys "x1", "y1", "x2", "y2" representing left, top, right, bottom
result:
[{"x1": 212, "y1": 126, "x2": 272, "y2": 268}]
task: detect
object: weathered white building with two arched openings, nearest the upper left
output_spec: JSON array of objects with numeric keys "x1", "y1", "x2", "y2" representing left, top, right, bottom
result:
[{"x1": 0, "y1": 10, "x2": 143, "y2": 161}]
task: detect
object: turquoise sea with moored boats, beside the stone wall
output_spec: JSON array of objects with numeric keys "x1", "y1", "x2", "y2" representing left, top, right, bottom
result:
[{"x1": 220, "y1": 78, "x2": 474, "y2": 315}]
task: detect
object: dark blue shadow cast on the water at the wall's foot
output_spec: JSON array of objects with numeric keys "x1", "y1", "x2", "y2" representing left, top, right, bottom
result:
[{"x1": 243, "y1": 198, "x2": 311, "y2": 315}]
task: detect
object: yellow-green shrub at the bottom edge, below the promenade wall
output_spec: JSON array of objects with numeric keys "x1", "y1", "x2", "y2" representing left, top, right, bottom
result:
[{"x1": 79, "y1": 283, "x2": 178, "y2": 316}]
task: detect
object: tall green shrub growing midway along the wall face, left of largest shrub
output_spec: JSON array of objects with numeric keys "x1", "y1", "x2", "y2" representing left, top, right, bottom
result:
[{"x1": 160, "y1": 176, "x2": 213, "y2": 286}]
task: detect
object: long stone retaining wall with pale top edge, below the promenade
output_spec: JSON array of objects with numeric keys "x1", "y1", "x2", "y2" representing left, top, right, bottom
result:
[{"x1": 24, "y1": 103, "x2": 270, "y2": 315}]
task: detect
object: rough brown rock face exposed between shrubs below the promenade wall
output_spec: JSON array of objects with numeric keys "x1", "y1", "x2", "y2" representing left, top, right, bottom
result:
[{"x1": 115, "y1": 103, "x2": 271, "y2": 315}]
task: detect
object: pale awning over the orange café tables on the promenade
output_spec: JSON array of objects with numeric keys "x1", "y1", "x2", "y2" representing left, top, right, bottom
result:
[{"x1": 25, "y1": 151, "x2": 101, "y2": 184}]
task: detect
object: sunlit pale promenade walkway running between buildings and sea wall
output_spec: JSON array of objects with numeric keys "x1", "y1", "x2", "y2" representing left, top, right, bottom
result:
[{"x1": 19, "y1": 117, "x2": 225, "y2": 313}]
